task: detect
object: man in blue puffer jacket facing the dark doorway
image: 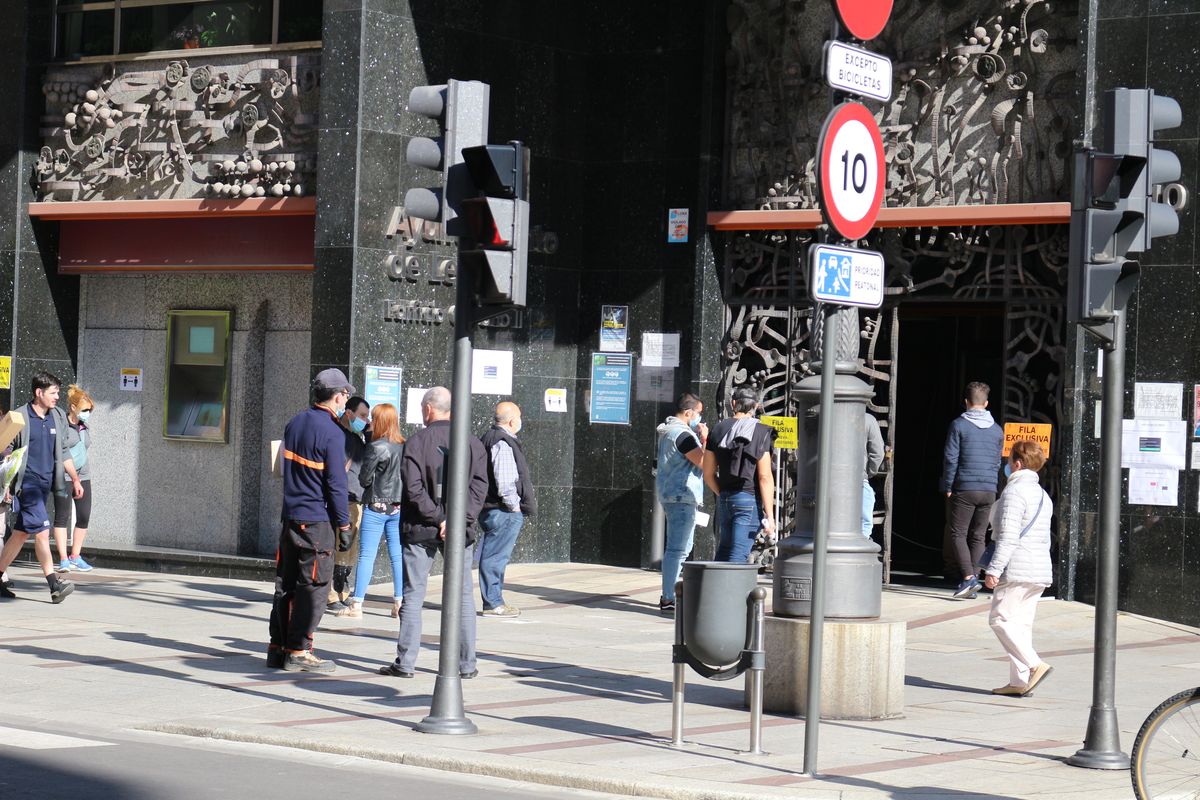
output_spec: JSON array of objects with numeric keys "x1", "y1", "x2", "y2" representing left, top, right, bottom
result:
[{"x1": 942, "y1": 381, "x2": 1004, "y2": 600}]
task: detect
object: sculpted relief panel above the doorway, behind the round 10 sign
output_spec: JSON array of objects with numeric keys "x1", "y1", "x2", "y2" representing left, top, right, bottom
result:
[{"x1": 725, "y1": 0, "x2": 1078, "y2": 209}]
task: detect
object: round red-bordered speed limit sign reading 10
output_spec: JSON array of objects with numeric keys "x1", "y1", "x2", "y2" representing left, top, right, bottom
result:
[{"x1": 817, "y1": 103, "x2": 886, "y2": 241}]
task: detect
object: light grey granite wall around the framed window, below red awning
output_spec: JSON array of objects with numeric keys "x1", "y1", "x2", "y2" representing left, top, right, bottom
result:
[{"x1": 79, "y1": 273, "x2": 312, "y2": 555}]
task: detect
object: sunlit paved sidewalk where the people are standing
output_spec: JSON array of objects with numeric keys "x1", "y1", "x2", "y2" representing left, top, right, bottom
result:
[{"x1": 0, "y1": 564, "x2": 1200, "y2": 800}]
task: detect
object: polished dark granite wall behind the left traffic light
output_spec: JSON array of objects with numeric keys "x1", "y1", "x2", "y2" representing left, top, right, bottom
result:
[{"x1": 312, "y1": 1, "x2": 720, "y2": 565}]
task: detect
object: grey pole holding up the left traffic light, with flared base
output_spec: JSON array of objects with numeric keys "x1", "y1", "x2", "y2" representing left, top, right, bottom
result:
[{"x1": 416, "y1": 273, "x2": 479, "y2": 734}]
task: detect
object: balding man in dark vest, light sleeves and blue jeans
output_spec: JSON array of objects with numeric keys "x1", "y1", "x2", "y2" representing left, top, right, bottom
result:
[{"x1": 479, "y1": 401, "x2": 538, "y2": 616}]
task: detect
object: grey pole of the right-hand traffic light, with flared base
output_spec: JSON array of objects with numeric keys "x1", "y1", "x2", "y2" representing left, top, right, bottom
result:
[{"x1": 1067, "y1": 275, "x2": 1138, "y2": 770}]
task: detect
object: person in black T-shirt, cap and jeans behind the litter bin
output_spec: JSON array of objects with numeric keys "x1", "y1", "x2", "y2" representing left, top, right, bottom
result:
[{"x1": 704, "y1": 389, "x2": 775, "y2": 564}]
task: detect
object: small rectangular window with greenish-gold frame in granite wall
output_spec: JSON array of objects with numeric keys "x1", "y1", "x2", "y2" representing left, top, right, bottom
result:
[{"x1": 162, "y1": 311, "x2": 233, "y2": 441}]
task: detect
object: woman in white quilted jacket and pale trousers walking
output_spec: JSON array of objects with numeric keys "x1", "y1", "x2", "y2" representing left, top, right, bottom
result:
[{"x1": 984, "y1": 441, "x2": 1054, "y2": 697}]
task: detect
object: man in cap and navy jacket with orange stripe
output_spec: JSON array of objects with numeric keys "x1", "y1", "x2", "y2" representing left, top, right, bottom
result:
[{"x1": 266, "y1": 369, "x2": 354, "y2": 672}]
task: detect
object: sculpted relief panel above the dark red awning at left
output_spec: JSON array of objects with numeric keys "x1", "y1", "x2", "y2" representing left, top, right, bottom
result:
[{"x1": 35, "y1": 53, "x2": 320, "y2": 200}]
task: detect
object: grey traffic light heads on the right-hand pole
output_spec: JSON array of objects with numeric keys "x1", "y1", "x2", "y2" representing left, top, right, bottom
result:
[{"x1": 1067, "y1": 89, "x2": 1182, "y2": 323}]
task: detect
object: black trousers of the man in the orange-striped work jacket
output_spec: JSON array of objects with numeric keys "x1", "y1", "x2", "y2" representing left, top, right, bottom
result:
[{"x1": 271, "y1": 519, "x2": 334, "y2": 650}]
